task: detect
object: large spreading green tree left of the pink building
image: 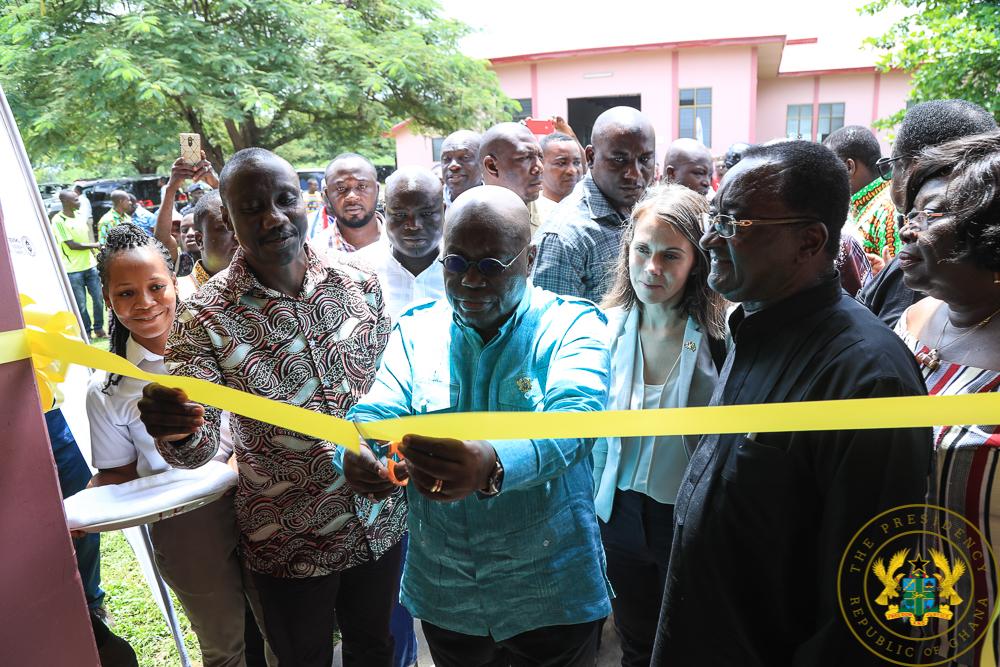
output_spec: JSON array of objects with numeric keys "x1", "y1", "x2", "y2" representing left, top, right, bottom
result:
[{"x1": 0, "y1": 0, "x2": 516, "y2": 171}]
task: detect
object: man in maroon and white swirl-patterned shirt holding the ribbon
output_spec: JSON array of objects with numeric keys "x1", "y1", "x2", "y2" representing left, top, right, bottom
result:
[{"x1": 139, "y1": 148, "x2": 405, "y2": 667}]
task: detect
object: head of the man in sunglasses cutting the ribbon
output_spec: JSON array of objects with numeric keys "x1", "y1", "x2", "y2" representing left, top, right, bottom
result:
[{"x1": 444, "y1": 185, "x2": 535, "y2": 341}]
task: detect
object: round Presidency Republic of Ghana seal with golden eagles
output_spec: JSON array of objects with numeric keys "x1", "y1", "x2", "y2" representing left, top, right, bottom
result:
[{"x1": 837, "y1": 505, "x2": 997, "y2": 665}]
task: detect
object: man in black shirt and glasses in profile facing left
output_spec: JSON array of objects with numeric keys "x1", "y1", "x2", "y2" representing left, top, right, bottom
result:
[{"x1": 652, "y1": 141, "x2": 931, "y2": 667}]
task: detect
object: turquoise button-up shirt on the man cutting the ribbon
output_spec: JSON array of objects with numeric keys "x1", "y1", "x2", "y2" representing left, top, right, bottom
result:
[{"x1": 348, "y1": 287, "x2": 611, "y2": 641}]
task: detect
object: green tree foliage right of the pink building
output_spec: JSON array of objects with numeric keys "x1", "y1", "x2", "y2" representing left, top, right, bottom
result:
[{"x1": 861, "y1": 0, "x2": 1000, "y2": 126}]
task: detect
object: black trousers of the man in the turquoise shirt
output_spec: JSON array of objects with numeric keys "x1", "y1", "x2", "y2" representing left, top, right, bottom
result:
[{"x1": 420, "y1": 619, "x2": 604, "y2": 667}]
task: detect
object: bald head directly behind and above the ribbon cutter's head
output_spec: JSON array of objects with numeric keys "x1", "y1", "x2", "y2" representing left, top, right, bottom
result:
[{"x1": 479, "y1": 123, "x2": 543, "y2": 204}]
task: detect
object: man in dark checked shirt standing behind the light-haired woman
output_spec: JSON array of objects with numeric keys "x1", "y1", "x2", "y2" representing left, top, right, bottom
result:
[{"x1": 533, "y1": 107, "x2": 656, "y2": 303}]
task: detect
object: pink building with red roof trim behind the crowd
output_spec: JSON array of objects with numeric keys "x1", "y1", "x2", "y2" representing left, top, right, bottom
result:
[{"x1": 392, "y1": 35, "x2": 910, "y2": 166}]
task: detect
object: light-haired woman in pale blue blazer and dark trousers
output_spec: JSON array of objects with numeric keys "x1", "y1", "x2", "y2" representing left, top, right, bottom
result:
[{"x1": 594, "y1": 184, "x2": 726, "y2": 667}]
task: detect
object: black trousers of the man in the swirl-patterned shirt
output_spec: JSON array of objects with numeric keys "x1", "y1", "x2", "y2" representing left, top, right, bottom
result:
[{"x1": 253, "y1": 544, "x2": 402, "y2": 667}]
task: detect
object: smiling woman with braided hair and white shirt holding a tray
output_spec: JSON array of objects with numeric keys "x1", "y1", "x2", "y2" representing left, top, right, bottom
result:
[{"x1": 87, "y1": 223, "x2": 260, "y2": 667}]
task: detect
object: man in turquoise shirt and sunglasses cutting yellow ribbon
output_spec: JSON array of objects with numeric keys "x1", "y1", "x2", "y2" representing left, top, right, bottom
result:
[{"x1": 341, "y1": 185, "x2": 611, "y2": 667}]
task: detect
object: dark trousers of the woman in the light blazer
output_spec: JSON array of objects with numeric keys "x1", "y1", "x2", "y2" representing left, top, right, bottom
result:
[{"x1": 600, "y1": 490, "x2": 674, "y2": 667}]
